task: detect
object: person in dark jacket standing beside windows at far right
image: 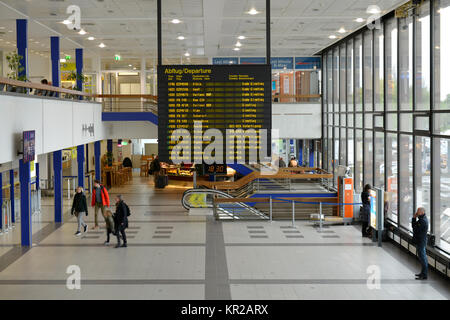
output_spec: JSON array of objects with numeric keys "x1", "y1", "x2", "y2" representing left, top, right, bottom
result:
[{"x1": 411, "y1": 208, "x2": 428, "y2": 280}]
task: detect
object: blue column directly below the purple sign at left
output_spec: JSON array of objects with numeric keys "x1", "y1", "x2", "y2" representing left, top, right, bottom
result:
[{"x1": 19, "y1": 159, "x2": 33, "y2": 247}]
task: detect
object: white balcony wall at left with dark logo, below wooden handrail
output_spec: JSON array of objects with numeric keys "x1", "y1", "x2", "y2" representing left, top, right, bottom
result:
[{"x1": 0, "y1": 94, "x2": 107, "y2": 164}]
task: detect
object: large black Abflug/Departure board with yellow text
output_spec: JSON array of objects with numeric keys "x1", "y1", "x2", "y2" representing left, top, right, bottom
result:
[{"x1": 158, "y1": 65, "x2": 272, "y2": 163}]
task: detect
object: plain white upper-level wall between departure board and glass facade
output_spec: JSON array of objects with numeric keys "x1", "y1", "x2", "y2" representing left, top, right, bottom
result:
[{"x1": 272, "y1": 103, "x2": 322, "y2": 139}]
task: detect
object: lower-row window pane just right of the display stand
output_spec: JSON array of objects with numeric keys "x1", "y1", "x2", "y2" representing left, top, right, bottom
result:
[{"x1": 386, "y1": 133, "x2": 398, "y2": 223}]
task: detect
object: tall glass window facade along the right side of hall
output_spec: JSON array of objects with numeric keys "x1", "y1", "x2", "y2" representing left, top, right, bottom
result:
[{"x1": 322, "y1": 0, "x2": 450, "y2": 252}]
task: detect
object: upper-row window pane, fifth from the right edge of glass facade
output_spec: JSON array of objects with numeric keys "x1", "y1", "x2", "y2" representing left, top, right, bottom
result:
[{"x1": 373, "y1": 28, "x2": 384, "y2": 111}]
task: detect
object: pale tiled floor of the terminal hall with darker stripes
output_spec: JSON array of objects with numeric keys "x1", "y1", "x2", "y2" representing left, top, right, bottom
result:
[{"x1": 0, "y1": 177, "x2": 450, "y2": 299}]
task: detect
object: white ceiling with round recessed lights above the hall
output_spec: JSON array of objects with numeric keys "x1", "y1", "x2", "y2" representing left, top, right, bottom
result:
[{"x1": 0, "y1": 0, "x2": 405, "y2": 64}]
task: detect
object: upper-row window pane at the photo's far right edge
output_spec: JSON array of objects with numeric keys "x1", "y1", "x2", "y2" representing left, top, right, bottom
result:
[{"x1": 433, "y1": 0, "x2": 450, "y2": 109}]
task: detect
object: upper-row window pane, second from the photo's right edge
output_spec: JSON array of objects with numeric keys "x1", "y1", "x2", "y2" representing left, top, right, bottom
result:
[{"x1": 416, "y1": 2, "x2": 431, "y2": 110}]
